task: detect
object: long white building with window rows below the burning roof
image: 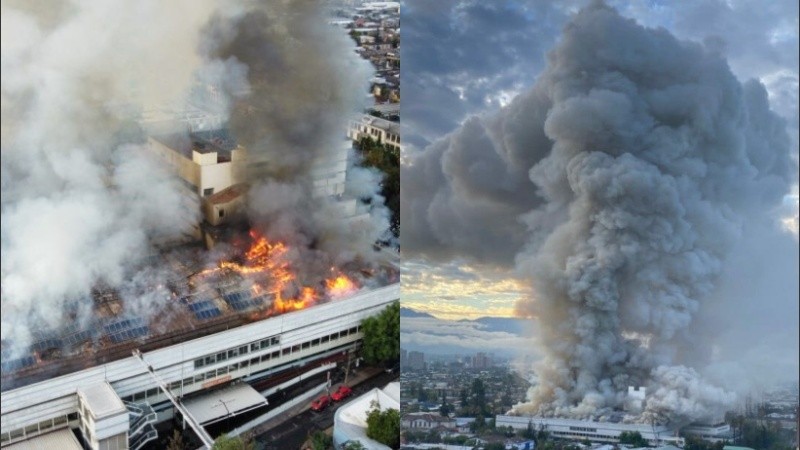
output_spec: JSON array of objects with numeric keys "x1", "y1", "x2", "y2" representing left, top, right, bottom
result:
[{"x1": 0, "y1": 283, "x2": 400, "y2": 450}]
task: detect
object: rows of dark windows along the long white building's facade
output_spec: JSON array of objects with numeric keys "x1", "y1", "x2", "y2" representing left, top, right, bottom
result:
[{"x1": 122, "y1": 326, "x2": 361, "y2": 402}]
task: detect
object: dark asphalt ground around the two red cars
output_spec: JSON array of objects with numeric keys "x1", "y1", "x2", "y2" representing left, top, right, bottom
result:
[{"x1": 255, "y1": 368, "x2": 398, "y2": 450}]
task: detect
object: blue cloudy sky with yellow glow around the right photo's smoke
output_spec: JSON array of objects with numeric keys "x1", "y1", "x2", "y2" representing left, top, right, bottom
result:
[{"x1": 402, "y1": 0, "x2": 798, "y2": 319}]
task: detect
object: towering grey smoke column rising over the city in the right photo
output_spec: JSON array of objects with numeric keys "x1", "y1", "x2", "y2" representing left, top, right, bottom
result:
[{"x1": 401, "y1": 2, "x2": 797, "y2": 422}]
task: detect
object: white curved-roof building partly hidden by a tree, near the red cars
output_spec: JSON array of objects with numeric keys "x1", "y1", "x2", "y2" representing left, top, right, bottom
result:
[{"x1": 333, "y1": 381, "x2": 400, "y2": 450}]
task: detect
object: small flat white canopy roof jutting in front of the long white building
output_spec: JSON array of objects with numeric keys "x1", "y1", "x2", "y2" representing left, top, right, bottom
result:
[{"x1": 183, "y1": 383, "x2": 267, "y2": 425}]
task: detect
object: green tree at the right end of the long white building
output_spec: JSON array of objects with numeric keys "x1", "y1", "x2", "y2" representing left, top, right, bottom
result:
[{"x1": 361, "y1": 302, "x2": 400, "y2": 364}]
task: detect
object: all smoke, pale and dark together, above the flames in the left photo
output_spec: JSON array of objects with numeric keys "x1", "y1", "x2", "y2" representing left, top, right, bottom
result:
[{"x1": 2, "y1": 0, "x2": 388, "y2": 356}]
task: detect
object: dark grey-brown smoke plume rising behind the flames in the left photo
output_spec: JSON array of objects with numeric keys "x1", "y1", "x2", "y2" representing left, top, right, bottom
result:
[{"x1": 204, "y1": 1, "x2": 388, "y2": 267}]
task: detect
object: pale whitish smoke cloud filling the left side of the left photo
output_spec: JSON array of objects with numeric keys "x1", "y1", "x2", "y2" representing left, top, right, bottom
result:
[{"x1": 2, "y1": 1, "x2": 219, "y2": 347}]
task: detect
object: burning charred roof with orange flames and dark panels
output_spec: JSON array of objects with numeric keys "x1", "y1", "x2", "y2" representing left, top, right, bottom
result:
[{"x1": 1, "y1": 241, "x2": 398, "y2": 391}]
